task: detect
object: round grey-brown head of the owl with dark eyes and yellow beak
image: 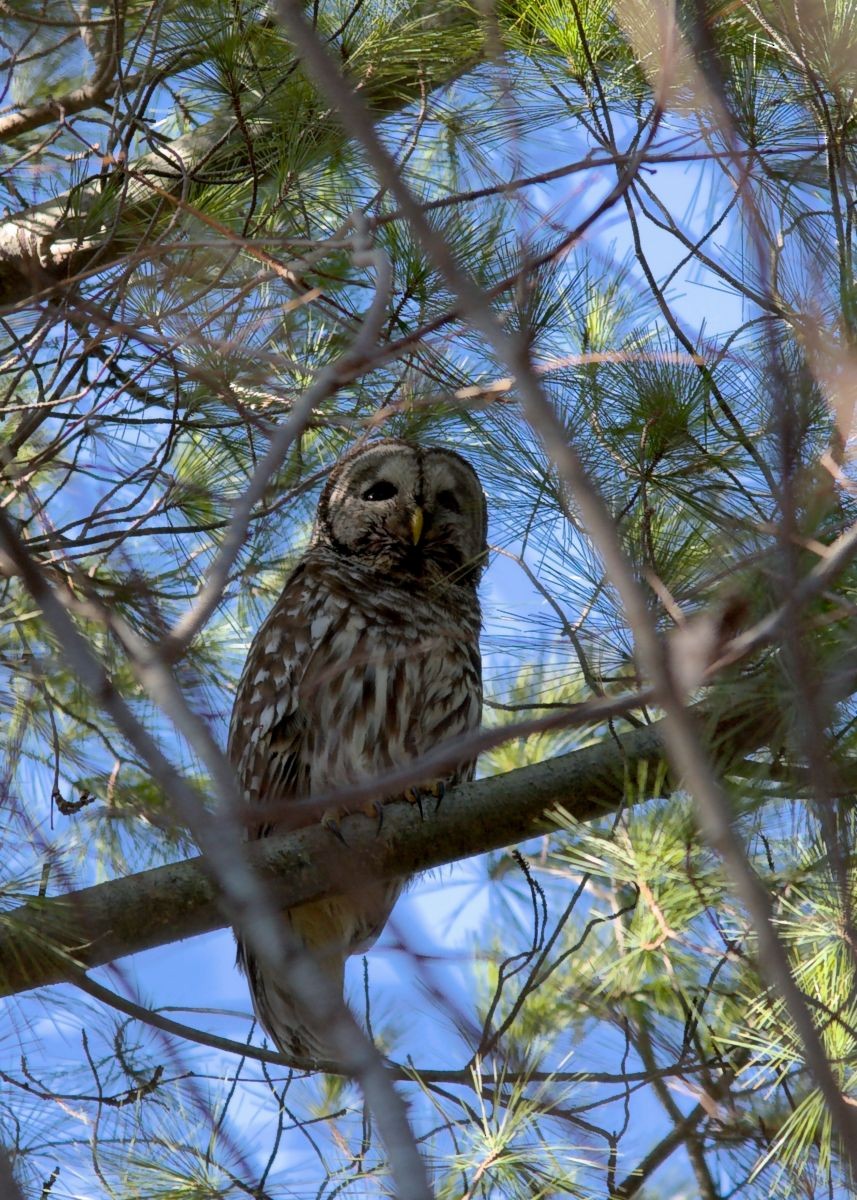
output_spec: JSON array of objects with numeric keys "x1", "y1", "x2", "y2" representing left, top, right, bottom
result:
[{"x1": 312, "y1": 438, "x2": 487, "y2": 587}]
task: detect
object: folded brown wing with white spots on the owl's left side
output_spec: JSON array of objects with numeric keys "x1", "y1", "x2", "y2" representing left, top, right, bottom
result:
[{"x1": 228, "y1": 564, "x2": 311, "y2": 839}]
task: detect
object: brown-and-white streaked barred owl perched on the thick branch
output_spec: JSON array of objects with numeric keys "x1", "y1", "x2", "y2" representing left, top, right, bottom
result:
[{"x1": 229, "y1": 438, "x2": 486, "y2": 1067}]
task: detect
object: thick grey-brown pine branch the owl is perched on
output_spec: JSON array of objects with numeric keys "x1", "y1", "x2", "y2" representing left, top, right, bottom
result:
[{"x1": 0, "y1": 722, "x2": 663, "y2": 996}]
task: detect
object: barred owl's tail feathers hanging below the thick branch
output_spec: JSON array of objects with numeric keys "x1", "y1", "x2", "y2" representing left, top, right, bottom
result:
[{"x1": 238, "y1": 940, "x2": 346, "y2": 1070}]
